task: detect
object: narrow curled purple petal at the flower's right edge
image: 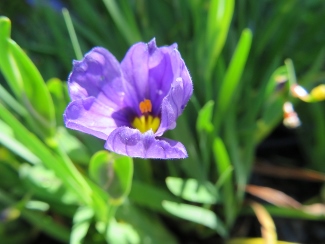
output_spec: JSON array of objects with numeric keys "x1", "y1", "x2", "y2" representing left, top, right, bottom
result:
[{"x1": 155, "y1": 65, "x2": 193, "y2": 136}]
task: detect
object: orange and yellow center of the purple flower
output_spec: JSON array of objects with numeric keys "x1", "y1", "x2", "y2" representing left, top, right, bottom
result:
[{"x1": 132, "y1": 99, "x2": 160, "y2": 133}]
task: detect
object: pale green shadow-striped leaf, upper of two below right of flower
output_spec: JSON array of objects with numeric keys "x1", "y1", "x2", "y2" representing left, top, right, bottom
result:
[{"x1": 166, "y1": 177, "x2": 219, "y2": 204}]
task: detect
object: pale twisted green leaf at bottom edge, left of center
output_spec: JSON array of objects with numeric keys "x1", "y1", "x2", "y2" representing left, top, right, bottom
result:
[{"x1": 70, "y1": 207, "x2": 94, "y2": 244}]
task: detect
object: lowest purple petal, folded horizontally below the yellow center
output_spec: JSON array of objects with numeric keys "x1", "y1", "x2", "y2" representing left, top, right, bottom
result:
[{"x1": 104, "y1": 127, "x2": 187, "y2": 159}]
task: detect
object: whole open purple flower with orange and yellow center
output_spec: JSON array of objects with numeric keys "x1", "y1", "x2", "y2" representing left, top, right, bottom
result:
[{"x1": 64, "y1": 39, "x2": 193, "y2": 159}]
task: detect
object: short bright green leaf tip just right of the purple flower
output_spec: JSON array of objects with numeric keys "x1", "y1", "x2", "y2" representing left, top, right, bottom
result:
[{"x1": 196, "y1": 101, "x2": 214, "y2": 133}]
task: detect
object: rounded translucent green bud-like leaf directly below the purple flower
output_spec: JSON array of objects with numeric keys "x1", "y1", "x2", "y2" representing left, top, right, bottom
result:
[{"x1": 89, "y1": 151, "x2": 133, "y2": 201}]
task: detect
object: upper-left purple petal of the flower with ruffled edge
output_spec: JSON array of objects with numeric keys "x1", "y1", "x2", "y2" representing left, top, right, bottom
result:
[{"x1": 68, "y1": 47, "x2": 124, "y2": 109}]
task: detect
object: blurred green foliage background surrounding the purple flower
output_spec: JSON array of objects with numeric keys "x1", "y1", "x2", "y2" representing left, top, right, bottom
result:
[{"x1": 0, "y1": 0, "x2": 325, "y2": 244}]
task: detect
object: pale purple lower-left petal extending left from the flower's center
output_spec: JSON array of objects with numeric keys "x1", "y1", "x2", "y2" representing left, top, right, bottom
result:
[{"x1": 63, "y1": 97, "x2": 129, "y2": 140}]
